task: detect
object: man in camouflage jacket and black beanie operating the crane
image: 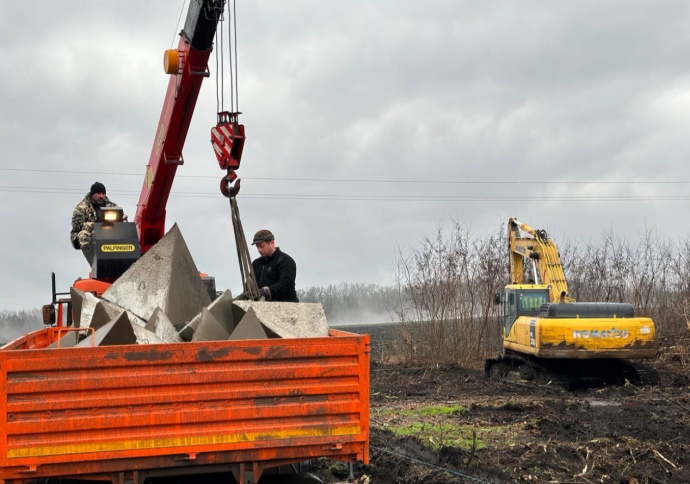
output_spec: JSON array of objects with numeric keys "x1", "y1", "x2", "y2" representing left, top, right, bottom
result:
[{"x1": 69, "y1": 182, "x2": 124, "y2": 265}]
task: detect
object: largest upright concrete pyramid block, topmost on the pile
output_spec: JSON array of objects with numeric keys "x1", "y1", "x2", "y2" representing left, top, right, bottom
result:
[{"x1": 102, "y1": 224, "x2": 211, "y2": 325}]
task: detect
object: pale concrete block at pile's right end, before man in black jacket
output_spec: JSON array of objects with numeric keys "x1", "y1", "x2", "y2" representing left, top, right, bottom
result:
[{"x1": 233, "y1": 301, "x2": 328, "y2": 338}]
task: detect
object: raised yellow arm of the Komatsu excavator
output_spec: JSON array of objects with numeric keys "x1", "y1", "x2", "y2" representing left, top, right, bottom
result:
[{"x1": 508, "y1": 218, "x2": 575, "y2": 302}]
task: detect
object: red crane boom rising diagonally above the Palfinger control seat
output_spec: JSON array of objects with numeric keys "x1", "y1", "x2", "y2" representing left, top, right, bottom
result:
[{"x1": 134, "y1": 0, "x2": 225, "y2": 254}]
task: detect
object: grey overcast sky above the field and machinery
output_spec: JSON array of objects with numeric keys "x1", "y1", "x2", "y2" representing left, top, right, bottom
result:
[{"x1": 0, "y1": 0, "x2": 690, "y2": 309}]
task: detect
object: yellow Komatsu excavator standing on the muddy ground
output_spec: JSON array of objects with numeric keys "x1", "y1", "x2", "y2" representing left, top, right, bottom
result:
[{"x1": 485, "y1": 218, "x2": 658, "y2": 388}]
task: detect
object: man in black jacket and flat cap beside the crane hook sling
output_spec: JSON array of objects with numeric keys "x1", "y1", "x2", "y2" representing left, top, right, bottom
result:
[{"x1": 252, "y1": 229, "x2": 299, "y2": 302}]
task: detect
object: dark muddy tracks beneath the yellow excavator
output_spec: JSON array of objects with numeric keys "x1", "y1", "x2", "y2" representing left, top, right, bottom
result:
[{"x1": 484, "y1": 354, "x2": 658, "y2": 390}]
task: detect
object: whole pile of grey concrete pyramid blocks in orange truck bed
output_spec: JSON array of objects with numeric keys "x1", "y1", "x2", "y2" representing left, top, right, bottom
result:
[{"x1": 60, "y1": 225, "x2": 328, "y2": 347}]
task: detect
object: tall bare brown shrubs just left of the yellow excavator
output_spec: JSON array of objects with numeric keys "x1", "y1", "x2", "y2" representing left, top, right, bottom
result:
[{"x1": 392, "y1": 222, "x2": 508, "y2": 364}]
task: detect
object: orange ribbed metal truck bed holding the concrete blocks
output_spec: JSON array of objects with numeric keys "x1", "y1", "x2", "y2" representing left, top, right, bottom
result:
[{"x1": 0, "y1": 328, "x2": 369, "y2": 483}]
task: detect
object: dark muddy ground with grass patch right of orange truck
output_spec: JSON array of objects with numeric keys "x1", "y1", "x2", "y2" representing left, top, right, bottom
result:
[{"x1": 318, "y1": 335, "x2": 690, "y2": 484}]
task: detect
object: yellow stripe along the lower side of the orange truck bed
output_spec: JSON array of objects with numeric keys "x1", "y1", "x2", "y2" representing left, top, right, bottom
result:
[{"x1": 7, "y1": 425, "x2": 362, "y2": 459}]
